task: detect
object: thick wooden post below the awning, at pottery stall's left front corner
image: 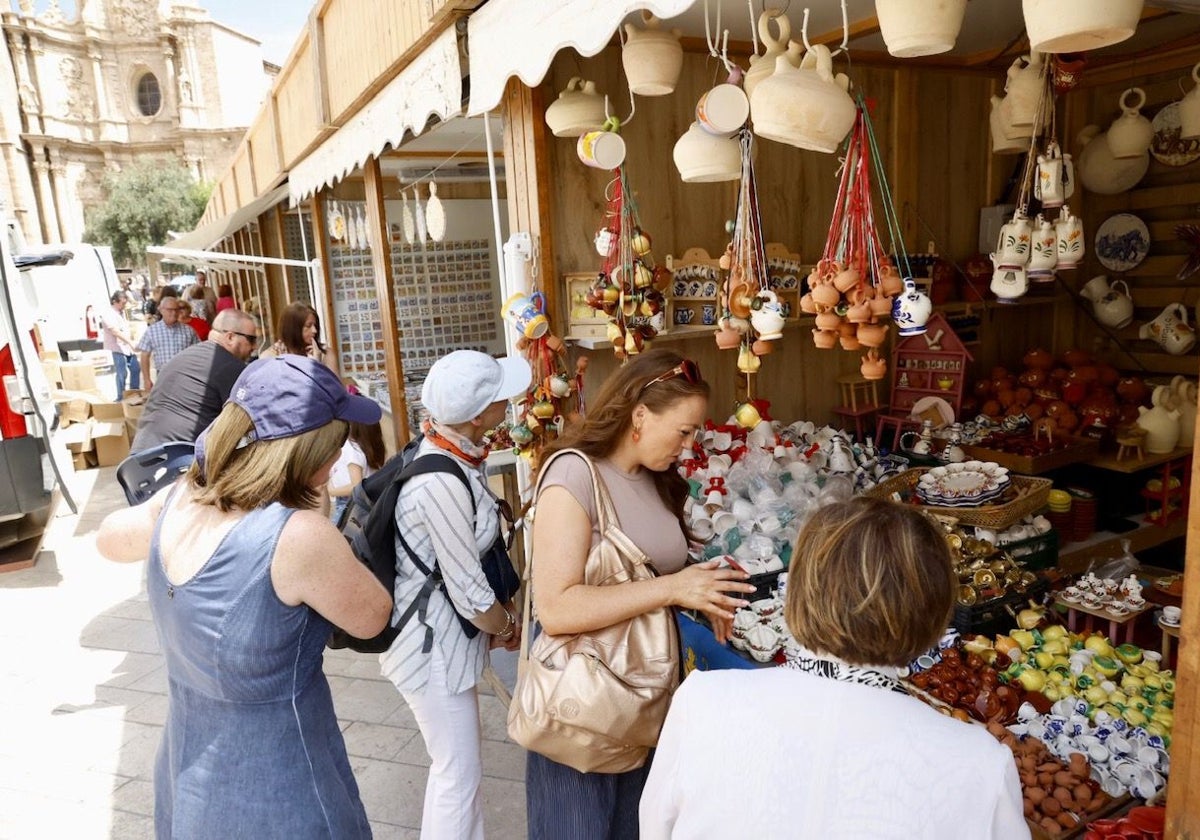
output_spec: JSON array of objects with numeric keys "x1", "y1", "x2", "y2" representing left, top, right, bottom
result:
[{"x1": 497, "y1": 79, "x2": 556, "y2": 334}]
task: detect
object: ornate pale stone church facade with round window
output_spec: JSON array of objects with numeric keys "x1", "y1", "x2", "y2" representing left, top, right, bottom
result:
[{"x1": 0, "y1": 0, "x2": 278, "y2": 244}]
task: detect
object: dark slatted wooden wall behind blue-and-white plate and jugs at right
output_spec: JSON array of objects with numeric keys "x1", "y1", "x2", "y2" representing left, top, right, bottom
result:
[{"x1": 1062, "y1": 62, "x2": 1200, "y2": 380}]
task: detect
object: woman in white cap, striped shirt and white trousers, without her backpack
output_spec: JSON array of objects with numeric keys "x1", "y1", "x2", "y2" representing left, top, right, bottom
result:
[{"x1": 380, "y1": 350, "x2": 532, "y2": 840}]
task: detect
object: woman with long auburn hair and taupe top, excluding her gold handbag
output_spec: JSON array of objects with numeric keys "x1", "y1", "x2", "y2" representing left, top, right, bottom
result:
[{"x1": 526, "y1": 350, "x2": 754, "y2": 840}]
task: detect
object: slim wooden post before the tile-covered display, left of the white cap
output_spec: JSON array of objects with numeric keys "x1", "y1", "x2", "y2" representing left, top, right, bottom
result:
[{"x1": 362, "y1": 157, "x2": 412, "y2": 452}]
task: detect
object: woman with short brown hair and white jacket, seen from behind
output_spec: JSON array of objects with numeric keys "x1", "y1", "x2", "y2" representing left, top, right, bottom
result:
[{"x1": 643, "y1": 497, "x2": 1030, "y2": 840}]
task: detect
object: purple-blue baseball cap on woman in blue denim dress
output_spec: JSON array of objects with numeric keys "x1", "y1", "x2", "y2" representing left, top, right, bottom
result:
[{"x1": 229, "y1": 353, "x2": 383, "y2": 440}]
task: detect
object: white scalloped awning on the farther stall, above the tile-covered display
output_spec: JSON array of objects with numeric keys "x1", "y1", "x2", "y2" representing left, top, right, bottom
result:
[{"x1": 288, "y1": 26, "x2": 462, "y2": 205}]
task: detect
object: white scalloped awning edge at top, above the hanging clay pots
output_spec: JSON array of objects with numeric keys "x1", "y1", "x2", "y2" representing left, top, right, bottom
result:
[{"x1": 467, "y1": 0, "x2": 695, "y2": 116}]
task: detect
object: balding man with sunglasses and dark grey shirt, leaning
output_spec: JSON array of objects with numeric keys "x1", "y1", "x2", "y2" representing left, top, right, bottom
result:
[{"x1": 130, "y1": 310, "x2": 258, "y2": 452}]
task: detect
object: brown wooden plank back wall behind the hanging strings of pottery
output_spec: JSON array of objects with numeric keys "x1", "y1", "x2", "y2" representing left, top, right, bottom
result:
[{"x1": 540, "y1": 47, "x2": 1052, "y2": 422}]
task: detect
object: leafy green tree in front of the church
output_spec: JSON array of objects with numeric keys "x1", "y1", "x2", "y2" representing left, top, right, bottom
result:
[{"x1": 84, "y1": 158, "x2": 212, "y2": 268}]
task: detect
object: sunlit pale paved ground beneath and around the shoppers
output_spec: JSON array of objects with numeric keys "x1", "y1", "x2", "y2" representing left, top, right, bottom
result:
[{"x1": 0, "y1": 468, "x2": 526, "y2": 840}]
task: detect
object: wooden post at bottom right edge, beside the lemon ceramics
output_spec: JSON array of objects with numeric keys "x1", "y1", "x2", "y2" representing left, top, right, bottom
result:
[{"x1": 1164, "y1": 396, "x2": 1200, "y2": 838}]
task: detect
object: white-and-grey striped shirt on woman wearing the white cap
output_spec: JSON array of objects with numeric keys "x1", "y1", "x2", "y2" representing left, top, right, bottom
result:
[{"x1": 379, "y1": 440, "x2": 500, "y2": 694}]
